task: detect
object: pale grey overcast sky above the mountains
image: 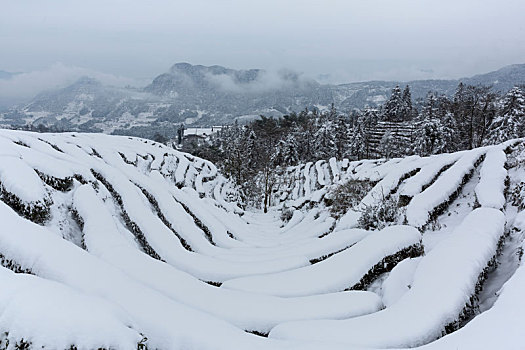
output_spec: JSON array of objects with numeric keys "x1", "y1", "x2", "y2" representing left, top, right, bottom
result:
[{"x1": 0, "y1": 0, "x2": 525, "y2": 87}]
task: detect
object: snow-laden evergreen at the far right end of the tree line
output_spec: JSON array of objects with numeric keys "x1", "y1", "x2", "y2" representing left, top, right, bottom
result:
[{"x1": 484, "y1": 87, "x2": 525, "y2": 145}]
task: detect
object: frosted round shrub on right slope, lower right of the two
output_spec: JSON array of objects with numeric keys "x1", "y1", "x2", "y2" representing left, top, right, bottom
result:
[{"x1": 358, "y1": 197, "x2": 400, "y2": 230}]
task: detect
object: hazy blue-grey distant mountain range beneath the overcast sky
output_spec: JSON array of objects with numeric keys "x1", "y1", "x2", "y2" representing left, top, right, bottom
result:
[{"x1": 0, "y1": 63, "x2": 525, "y2": 137}]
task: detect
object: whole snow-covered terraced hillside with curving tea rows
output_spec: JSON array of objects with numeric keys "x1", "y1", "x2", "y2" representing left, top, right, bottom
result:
[{"x1": 0, "y1": 130, "x2": 525, "y2": 350}]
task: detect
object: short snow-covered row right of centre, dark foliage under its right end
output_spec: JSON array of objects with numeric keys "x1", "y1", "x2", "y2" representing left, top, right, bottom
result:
[{"x1": 221, "y1": 226, "x2": 421, "y2": 297}]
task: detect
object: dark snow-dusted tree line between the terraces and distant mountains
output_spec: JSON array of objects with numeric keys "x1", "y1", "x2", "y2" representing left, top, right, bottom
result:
[{"x1": 184, "y1": 83, "x2": 525, "y2": 206}]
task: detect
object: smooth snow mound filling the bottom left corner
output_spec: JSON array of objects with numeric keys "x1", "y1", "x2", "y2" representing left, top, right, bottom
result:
[{"x1": 0, "y1": 267, "x2": 143, "y2": 349}]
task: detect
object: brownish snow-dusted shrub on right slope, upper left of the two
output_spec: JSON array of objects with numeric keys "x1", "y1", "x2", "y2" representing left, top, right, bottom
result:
[{"x1": 325, "y1": 180, "x2": 373, "y2": 217}]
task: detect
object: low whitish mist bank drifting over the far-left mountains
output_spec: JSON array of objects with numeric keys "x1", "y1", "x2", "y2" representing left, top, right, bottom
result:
[{"x1": 0, "y1": 63, "x2": 143, "y2": 106}]
